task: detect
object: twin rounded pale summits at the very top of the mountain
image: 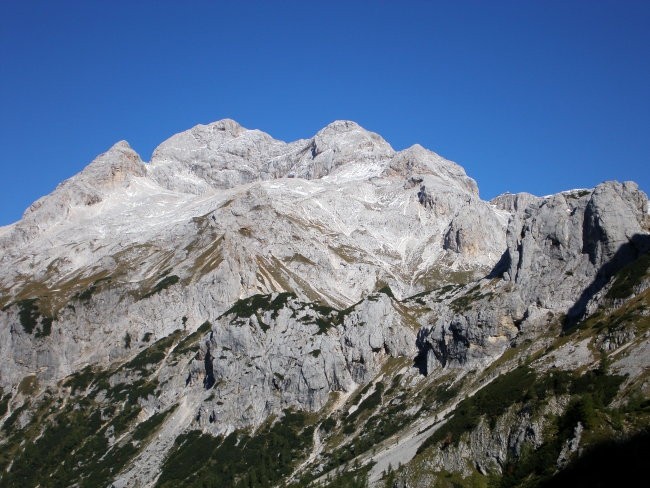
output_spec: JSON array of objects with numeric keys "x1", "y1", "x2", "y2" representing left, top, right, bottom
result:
[{"x1": 148, "y1": 120, "x2": 395, "y2": 193}]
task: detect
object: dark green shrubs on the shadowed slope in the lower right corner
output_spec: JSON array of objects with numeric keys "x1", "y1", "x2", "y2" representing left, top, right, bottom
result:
[{"x1": 408, "y1": 356, "x2": 632, "y2": 488}]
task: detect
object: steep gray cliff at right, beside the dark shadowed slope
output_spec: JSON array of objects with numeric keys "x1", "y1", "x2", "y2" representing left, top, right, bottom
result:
[{"x1": 418, "y1": 182, "x2": 648, "y2": 371}]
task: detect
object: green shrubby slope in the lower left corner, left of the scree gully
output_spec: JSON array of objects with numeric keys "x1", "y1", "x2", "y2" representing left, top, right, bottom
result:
[{"x1": 0, "y1": 342, "x2": 174, "y2": 488}]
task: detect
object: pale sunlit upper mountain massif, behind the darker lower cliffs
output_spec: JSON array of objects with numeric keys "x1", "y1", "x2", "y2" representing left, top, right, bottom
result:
[{"x1": 0, "y1": 120, "x2": 507, "y2": 394}]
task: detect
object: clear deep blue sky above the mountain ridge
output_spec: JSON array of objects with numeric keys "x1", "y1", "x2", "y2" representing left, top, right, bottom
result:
[{"x1": 0, "y1": 0, "x2": 650, "y2": 225}]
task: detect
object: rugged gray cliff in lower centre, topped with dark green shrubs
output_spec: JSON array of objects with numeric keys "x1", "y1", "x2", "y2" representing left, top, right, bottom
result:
[{"x1": 159, "y1": 294, "x2": 416, "y2": 434}]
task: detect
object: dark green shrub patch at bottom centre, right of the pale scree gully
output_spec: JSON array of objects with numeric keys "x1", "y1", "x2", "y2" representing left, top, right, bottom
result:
[{"x1": 156, "y1": 411, "x2": 313, "y2": 488}]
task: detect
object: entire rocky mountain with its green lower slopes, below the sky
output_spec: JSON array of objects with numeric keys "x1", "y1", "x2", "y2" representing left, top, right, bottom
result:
[{"x1": 0, "y1": 120, "x2": 650, "y2": 488}]
